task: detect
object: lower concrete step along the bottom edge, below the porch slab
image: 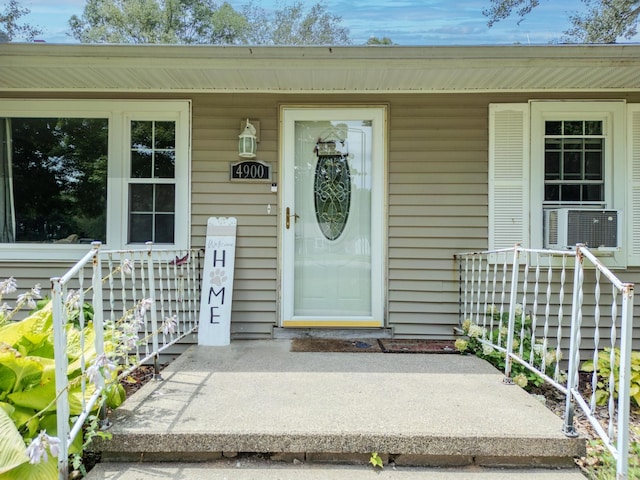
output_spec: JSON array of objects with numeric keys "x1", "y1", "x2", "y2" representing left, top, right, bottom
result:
[{"x1": 85, "y1": 459, "x2": 585, "y2": 480}]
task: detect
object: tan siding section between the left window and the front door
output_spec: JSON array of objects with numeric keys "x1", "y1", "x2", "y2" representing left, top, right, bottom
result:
[{"x1": 191, "y1": 94, "x2": 280, "y2": 339}]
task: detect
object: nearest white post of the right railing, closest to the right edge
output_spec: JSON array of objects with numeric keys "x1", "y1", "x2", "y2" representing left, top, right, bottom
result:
[{"x1": 612, "y1": 283, "x2": 633, "y2": 480}]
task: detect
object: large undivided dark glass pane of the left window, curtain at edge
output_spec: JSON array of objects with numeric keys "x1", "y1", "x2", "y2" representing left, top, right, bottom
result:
[{"x1": 0, "y1": 117, "x2": 109, "y2": 244}]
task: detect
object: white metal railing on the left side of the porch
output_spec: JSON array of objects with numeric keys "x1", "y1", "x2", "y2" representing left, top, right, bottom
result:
[{"x1": 51, "y1": 242, "x2": 202, "y2": 480}]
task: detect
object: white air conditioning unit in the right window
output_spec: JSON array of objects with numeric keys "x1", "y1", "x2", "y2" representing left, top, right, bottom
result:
[{"x1": 544, "y1": 208, "x2": 622, "y2": 251}]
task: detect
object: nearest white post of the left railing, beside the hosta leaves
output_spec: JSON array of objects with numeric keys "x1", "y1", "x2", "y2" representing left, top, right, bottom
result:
[{"x1": 51, "y1": 277, "x2": 70, "y2": 480}]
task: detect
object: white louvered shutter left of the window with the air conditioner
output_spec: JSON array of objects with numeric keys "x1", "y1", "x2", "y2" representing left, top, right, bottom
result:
[{"x1": 489, "y1": 103, "x2": 528, "y2": 250}]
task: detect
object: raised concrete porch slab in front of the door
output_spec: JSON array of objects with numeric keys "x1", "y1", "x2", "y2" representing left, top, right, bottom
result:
[{"x1": 88, "y1": 340, "x2": 585, "y2": 480}]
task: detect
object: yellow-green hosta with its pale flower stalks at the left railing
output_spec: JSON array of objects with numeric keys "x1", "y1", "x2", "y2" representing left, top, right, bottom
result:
[{"x1": 0, "y1": 272, "x2": 145, "y2": 480}]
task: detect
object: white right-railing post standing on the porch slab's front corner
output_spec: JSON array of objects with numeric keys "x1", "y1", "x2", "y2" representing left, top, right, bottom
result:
[{"x1": 562, "y1": 245, "x2": 584, "y2": 437}]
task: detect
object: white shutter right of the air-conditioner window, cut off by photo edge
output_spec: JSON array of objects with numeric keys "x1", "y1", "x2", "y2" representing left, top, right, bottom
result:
[{"x1": 623, "y1": 104, "x2": 640, "y2": 266}]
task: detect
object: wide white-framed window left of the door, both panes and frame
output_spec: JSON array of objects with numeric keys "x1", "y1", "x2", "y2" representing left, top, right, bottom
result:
[{"x1": 0, "y1": 100, "x2": 190, "y2": 260}]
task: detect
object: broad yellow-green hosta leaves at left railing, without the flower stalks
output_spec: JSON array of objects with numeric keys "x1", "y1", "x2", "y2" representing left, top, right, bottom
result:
[{"x1": 0, "y1": 292, "x2": 124, "y2": 480}]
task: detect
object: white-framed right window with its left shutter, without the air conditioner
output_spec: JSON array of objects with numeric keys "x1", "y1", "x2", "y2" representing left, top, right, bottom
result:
[{"x1": 489, "y1": 101, "x2": 640, "y2": 266}]
